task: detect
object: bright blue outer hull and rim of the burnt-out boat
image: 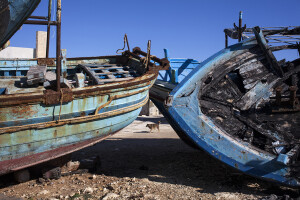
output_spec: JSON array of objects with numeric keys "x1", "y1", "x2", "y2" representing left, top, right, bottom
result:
[{"x1": 150, "y1": 30, "x2": 300, "y2": 187}]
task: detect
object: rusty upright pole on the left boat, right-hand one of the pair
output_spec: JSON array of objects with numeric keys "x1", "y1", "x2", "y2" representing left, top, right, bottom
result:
[{"x1": 56, "y1": 0, "x2": 61, "y2": 92}]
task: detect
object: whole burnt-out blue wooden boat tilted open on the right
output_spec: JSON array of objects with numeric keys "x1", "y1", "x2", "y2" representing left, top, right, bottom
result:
[{"x1": 150, "y1": 27, "x2": 300, "y2": 187}]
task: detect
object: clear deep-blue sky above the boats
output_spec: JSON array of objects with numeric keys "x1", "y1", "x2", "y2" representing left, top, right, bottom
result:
[{"x1": 11, "y1": 0, "x2": 300, "y2": 61}]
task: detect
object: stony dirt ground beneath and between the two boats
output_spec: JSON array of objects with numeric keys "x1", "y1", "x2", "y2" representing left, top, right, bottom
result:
[{"x1": 0, "y1": 116, "x2": 298, "y2": 200}]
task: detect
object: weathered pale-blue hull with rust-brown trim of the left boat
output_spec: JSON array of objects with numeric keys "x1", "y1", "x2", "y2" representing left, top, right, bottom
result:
[{"x1": 0, "y1": 56, "x2": 158, "y2": 175}]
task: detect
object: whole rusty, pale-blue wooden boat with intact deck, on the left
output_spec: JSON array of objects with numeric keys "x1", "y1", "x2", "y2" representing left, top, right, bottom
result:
[{"x1": 0, "y1": 0, "x2": 169, "y2": 175}]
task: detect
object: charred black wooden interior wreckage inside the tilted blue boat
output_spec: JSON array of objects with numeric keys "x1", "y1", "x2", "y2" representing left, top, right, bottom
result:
[{"x1": 199, "y1": 27, "x2": 300, "y2": 177}]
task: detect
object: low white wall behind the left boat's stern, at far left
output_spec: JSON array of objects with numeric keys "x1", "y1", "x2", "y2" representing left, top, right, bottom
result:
[{"x1": 0, "y1": 47, "x2": 35, "y2": 58}]
